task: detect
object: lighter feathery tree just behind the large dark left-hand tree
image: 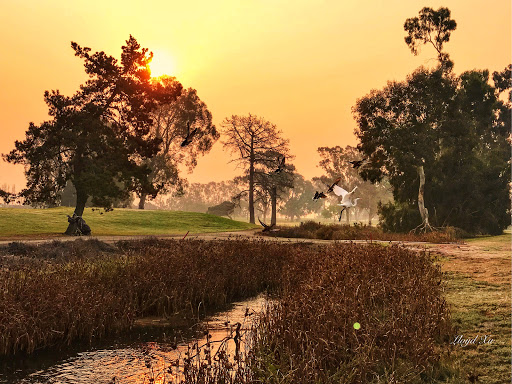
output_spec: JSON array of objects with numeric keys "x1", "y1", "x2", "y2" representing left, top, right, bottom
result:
[{"x1": 136, "y1": 76, "x2": 220, "y2": 209}]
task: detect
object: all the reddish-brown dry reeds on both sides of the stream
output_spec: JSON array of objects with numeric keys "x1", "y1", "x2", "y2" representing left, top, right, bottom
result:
[{"x1": 0, "y1": 239, "x2": 450, "y2": 383}]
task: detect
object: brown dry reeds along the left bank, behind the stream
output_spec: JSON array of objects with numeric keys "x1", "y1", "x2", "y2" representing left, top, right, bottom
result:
[{"x1": 0, "y1": 239, "x2": 297, "y2": 355}]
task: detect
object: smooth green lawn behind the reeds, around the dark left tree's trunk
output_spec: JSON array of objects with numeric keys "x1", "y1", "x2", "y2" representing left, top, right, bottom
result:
[{"x1": 0, "y1": 207, "x2": 257, "y2": 238}]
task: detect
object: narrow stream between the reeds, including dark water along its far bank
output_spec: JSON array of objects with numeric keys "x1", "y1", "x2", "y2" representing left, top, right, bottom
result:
[{"x1": 0, "y1": 296, "x2": 266, "y2": 384}]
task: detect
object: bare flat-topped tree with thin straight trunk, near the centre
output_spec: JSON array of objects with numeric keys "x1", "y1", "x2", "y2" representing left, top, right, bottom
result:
[{"x1": 222, "y1": 114, "x2": 288, "y2": 224}]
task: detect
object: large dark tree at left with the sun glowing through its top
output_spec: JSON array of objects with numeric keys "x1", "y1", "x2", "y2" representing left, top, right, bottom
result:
[{"x1": 5, "y1": 36, "x2": 181, "y2": 233}]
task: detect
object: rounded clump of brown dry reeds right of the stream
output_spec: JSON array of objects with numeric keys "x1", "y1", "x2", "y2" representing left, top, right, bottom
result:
[{"x1": 248, "y1": 244, "x2": 450, "y2": 383}]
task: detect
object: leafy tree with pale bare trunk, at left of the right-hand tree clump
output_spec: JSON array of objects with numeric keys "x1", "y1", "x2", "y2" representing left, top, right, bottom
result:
[{"x1": 353, "y1": 68, "x2": 455, "y2": 229}]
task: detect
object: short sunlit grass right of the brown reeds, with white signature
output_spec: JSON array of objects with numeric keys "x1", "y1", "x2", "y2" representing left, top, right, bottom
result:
[{"x1": 442, "y1": 233, "x2": 512, "y2": 384}]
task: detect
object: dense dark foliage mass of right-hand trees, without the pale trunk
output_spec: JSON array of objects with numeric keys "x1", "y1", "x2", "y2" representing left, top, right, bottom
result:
[{"x1": 353, "y1": 67, "x2": 510, "y2": 234}]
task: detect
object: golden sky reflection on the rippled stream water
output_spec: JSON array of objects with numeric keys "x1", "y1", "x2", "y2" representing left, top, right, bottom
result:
[{"x1": 0, "y1": 296, "x2": 266, "y2": 384}]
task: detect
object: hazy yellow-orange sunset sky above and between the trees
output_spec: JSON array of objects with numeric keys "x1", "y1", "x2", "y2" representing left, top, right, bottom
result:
[{"x1": 0, "y1": 0, "x2": 511, "y2": 191}]
